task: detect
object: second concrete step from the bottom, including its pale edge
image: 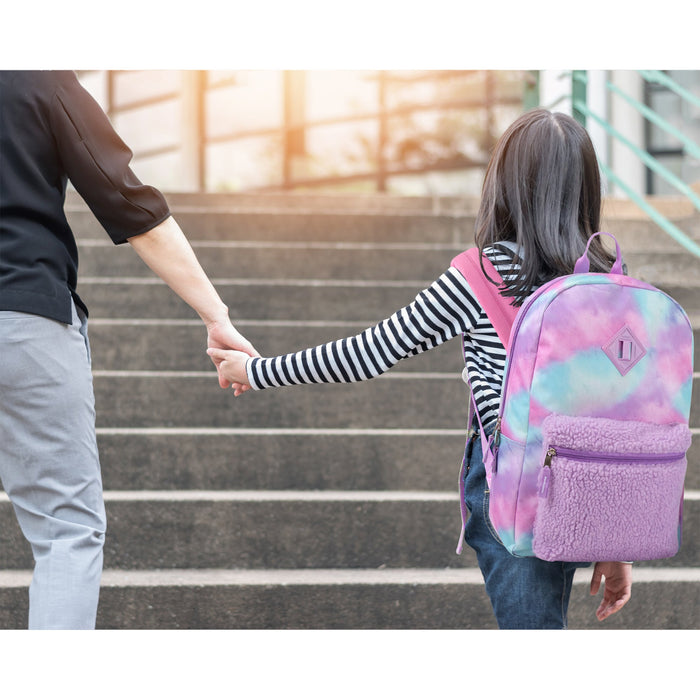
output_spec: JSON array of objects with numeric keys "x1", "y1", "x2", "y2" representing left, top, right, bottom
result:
[{"x1": 0, "y1": 489, "x2": 700, "y2": 569}]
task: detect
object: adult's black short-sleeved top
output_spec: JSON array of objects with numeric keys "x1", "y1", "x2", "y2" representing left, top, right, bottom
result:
[{"x1": 0, "y1": 71, "x2": 170, "y2": 323}]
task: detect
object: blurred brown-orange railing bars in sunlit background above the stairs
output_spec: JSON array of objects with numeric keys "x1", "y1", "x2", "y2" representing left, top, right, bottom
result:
[{"x1": 83, "y1": 70, "x2": 523, "y2": 192}]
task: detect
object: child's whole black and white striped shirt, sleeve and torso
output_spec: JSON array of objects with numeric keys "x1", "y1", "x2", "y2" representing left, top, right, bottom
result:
[{"x1": 246, "y1": 244, "x2": 519, "y2": 425}]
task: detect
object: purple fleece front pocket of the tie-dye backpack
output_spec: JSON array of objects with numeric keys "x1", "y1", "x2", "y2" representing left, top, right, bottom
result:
[{"x1": 533, "y1": 414, "x2": 691, "y2": 561}]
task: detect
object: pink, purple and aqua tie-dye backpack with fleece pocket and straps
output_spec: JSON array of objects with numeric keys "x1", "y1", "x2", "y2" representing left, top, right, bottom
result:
[{"x1": 452, "y1": 234, "x2": 693, "y2": 562}]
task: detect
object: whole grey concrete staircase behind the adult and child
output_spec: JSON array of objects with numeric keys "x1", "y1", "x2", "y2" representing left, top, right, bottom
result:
[{"x1": 0, "y1": 194, "x2": 700, "y2": 629}]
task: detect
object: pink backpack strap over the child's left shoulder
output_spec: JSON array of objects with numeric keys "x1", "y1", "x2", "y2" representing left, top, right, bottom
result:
[{"x1": 452, "y1": 248, "x2": 518, "y2": 350}]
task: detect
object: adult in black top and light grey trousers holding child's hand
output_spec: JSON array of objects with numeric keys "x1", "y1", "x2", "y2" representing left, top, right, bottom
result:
[{"x1": 0, "y1": 71, "x2": 256, "y2": 629}]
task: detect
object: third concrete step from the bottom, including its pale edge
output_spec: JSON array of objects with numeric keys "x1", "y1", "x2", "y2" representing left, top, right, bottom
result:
[{"x1": 93, "y1": 427, "x2": 700, "y2": 492}]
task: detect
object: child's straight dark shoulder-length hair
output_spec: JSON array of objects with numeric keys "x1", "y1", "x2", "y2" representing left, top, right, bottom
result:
[{"x1": 475, "y1": 109, "x2": 614, "y2": 306}]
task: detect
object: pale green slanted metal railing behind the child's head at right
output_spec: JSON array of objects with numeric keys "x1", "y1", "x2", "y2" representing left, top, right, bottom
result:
[{"x1": 571, "y1": 70, "x2": 700, "y2": 257}]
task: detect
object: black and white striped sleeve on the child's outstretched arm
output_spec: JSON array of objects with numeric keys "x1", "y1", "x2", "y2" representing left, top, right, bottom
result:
[{"x1": 246, "y1": 268, "x2": 481, "y2": 390}]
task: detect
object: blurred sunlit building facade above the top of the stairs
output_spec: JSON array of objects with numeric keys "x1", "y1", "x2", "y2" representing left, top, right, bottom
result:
[{"x1": 79, "y1": 70, "x2": 700, "y2": 195}]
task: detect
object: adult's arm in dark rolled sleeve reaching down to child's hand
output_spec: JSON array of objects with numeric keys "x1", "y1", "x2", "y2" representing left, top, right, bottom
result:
[{"x1": 50, "y1": 71, "x2": 257, "y2": 388}]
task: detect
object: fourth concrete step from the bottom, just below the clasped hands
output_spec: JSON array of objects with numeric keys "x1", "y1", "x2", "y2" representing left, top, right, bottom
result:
[{"x1": 87, "y1": 374, "x2": 700, "y2": 429}]
